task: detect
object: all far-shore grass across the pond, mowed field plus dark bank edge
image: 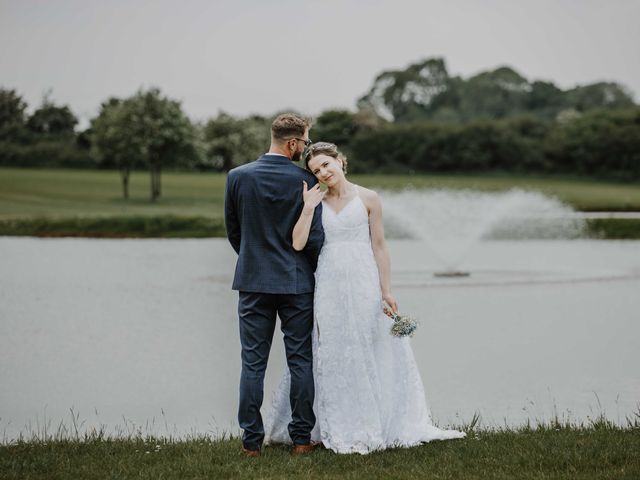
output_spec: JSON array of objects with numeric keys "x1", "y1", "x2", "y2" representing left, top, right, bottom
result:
[{"x1": 0, "y1": 168, "x2": 640, "y2": 239}]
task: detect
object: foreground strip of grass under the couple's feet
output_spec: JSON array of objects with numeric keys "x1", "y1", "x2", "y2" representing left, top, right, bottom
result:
[{"x1": 0, "y1": 418, "x2": 640, "y2": 480}]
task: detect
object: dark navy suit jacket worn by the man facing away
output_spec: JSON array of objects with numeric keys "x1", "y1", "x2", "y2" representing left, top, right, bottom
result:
[{"x1": 224, "y1": 154, "x2": 324, "y2": 294}]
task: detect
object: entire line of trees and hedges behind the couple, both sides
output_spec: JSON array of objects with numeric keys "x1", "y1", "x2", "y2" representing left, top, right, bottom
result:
[{"x1": 0, "y1": 59, "x2": 640, "y2": 200}]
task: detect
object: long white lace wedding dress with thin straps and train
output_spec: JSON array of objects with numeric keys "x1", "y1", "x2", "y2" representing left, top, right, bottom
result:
[{"x1": 265, "y1": 188, "x2": 465, "y2": 454}]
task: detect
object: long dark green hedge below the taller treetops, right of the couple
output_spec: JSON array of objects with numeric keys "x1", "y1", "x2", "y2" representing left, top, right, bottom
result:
[{"x1": 350, "y1": 110, "x2": 640, "y2": 180}]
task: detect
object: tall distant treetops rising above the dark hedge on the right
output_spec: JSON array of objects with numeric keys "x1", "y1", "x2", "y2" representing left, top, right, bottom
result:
[{"x1": 358, "y1": 58, "x2": 635, "y2": 122}]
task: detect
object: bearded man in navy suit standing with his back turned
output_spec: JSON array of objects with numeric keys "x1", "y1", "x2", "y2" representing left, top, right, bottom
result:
[{"x1": 224, "y1": 113, "x2": 324, "y2": 457}]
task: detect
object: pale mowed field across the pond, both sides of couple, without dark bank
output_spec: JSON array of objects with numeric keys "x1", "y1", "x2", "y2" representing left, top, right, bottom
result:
[{"x1": 0, "y1": 168, "x2": 640, "y2": 219}]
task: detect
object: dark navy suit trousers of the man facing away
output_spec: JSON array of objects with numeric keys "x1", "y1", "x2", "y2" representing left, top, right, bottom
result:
[{"x1": 238, "y1": 292, "x2": 316, "y2": 450}]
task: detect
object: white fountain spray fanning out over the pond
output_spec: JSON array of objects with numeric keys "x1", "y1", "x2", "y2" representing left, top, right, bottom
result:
[{"x1": 381, "y1": 189, "x2": 585, "y2": 277}]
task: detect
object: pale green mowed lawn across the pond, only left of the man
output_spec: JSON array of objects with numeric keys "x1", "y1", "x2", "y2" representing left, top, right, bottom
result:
[{"x1": 0, "y1": 169, "x2": 225, "y2": 219}]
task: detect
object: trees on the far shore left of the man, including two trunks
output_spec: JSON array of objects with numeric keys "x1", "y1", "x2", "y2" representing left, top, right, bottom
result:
[{"x1": 0, "y1": 88, "x2": 272, "y2": 200}]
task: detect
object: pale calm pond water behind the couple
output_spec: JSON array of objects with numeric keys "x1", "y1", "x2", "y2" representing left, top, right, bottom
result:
[{"x1": 0, "y1": 237, "x2": 640, "y2": 441}]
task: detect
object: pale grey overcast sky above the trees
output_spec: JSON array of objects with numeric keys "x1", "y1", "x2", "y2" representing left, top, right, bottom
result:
[{"x1": 0, "y1": 0, "x2": 640, "y2": 125}]
